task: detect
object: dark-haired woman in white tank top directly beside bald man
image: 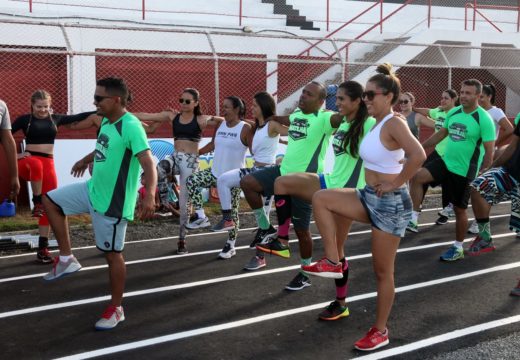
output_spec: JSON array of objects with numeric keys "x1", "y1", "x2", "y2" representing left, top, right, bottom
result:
[{"x1": 212, "y1": 92, "x2": 288, "y2": 259}]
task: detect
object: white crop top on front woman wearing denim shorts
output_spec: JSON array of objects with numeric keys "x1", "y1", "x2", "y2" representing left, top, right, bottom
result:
[{"x1": 359, "y1": 113, "x2": 404, "y2": 174}]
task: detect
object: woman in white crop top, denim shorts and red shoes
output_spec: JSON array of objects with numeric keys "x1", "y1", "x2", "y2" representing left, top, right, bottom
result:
[{"x1": 302, "y1": 64, "x2": 426, "y2": 351}]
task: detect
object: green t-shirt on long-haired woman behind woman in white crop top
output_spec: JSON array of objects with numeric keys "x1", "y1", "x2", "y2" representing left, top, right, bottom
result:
[{"x1": 324, "y1": 117, "x2": 376, "y2": 189}]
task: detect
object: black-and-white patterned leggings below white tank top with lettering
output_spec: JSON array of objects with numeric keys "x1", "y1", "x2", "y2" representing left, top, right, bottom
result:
[{"x1": 186, "y1": 168, "x2": 240, "y2": 240}]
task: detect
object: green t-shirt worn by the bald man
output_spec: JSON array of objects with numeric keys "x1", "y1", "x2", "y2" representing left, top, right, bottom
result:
[{"x1": 280, "y1": 109, "x2": 336, "y2": 175}]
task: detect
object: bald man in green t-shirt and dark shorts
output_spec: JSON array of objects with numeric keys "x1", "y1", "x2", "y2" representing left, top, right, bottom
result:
[{"x1": 240, "y1": 82, "x2": 342, "y2": 290}]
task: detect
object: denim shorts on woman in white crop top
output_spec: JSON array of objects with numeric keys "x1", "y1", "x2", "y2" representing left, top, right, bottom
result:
[{"x1": 356, "y1": 185, "x2": 412, "y2": 237}]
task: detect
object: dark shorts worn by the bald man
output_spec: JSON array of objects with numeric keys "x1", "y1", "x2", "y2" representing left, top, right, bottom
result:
[{"x1": 249, "y1": 165, "x2": 312, "y2": 230}]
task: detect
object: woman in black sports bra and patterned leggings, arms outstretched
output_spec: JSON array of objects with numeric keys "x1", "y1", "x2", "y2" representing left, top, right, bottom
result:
[{"x1": 134, "y1": 88, "x2": 223, "y2": 254}]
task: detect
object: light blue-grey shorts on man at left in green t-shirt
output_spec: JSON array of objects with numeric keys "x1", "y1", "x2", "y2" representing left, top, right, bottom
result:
[{"x1": 47, "y1": 182, "x2": 128, "y2": 252}]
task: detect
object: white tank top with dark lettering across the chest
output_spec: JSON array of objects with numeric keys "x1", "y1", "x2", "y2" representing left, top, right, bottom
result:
[{"x1": 211, "y1": 121, "x2": 247, "y2": 178}]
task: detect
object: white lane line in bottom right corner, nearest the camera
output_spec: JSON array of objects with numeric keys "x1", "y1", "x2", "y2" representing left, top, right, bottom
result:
[{"x1": 356, "y1": 315, "x2": 520, "y2": 360}]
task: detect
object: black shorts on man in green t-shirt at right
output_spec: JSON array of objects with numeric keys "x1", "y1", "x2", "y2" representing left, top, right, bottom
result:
[{"x1": 424, "y1": 158, "x2": 471, "y2": 209}]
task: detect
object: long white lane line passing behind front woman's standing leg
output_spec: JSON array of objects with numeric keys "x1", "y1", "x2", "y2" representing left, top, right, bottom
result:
[{"x1": 53, "y1": 262, "x2": 520, "y2": 360}]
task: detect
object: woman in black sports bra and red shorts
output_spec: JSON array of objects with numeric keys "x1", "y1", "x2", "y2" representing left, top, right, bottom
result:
[{"x1": 11, "y1": 90, "x2": 97, "y2": 264}]
